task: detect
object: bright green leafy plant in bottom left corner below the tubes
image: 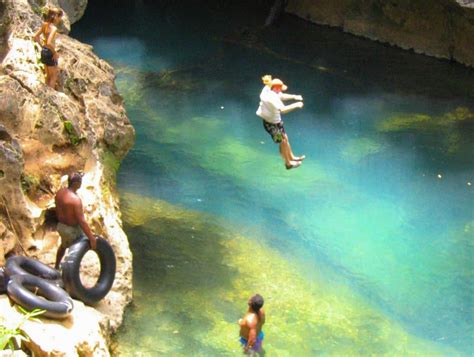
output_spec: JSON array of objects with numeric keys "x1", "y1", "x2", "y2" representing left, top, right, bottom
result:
[{"x1": 0, "y1": 305, "x2": 44, "y2": 350}]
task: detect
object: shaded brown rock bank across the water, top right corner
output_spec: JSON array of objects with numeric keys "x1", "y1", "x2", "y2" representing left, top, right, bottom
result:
[{"x1": 286, "y1": 0, "x2": 474, "y2": 66}]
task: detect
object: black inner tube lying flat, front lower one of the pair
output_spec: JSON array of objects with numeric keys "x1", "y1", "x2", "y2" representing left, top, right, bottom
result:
[{"x1": 7, "y1": 274, "x2": 73, "y2": 319}]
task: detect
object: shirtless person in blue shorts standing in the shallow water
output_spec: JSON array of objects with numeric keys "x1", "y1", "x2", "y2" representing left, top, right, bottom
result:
[{"x1": 239, "y1": 294, "x2": 265, "y2": 356}]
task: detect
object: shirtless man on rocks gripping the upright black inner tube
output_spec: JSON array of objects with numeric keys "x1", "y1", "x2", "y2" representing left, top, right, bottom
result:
[{"x1": 54, "y1": 173, "x2": 96, "y2": 269}]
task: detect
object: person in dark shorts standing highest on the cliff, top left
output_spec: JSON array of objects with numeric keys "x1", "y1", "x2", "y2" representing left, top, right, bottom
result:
[{"x1": 34, "y1": 7, "x2": 63, "y2": 89}]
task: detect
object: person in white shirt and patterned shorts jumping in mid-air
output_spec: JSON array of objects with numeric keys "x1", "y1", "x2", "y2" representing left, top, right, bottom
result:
[{"x1": 256, "y1": 75, "x2": 305, "y2": 170}]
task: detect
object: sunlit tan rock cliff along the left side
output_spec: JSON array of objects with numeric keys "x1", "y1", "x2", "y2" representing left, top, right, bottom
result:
[{"x1": 0, "y1": 0, "x2": 134, "y2": 355}]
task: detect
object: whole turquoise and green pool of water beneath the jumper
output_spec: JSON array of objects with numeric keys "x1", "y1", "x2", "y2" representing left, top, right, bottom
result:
[{"x1": 73, "y1": 5, "x2": 474, "y2": 355}]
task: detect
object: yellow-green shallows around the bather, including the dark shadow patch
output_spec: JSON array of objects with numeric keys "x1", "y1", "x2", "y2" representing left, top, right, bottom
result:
[{"x1": 114, "y1": 193, "x2": 458, "y2": 356}]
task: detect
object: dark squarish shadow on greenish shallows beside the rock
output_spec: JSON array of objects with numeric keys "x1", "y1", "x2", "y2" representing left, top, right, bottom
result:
[{"x1": 125, "y1": 217, "x2": 236, "y2": 293}]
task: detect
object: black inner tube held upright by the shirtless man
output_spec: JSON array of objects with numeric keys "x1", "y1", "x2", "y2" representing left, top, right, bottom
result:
[{"x1": 61, "y1": 237, "x2": 116, "y2": 305}]
